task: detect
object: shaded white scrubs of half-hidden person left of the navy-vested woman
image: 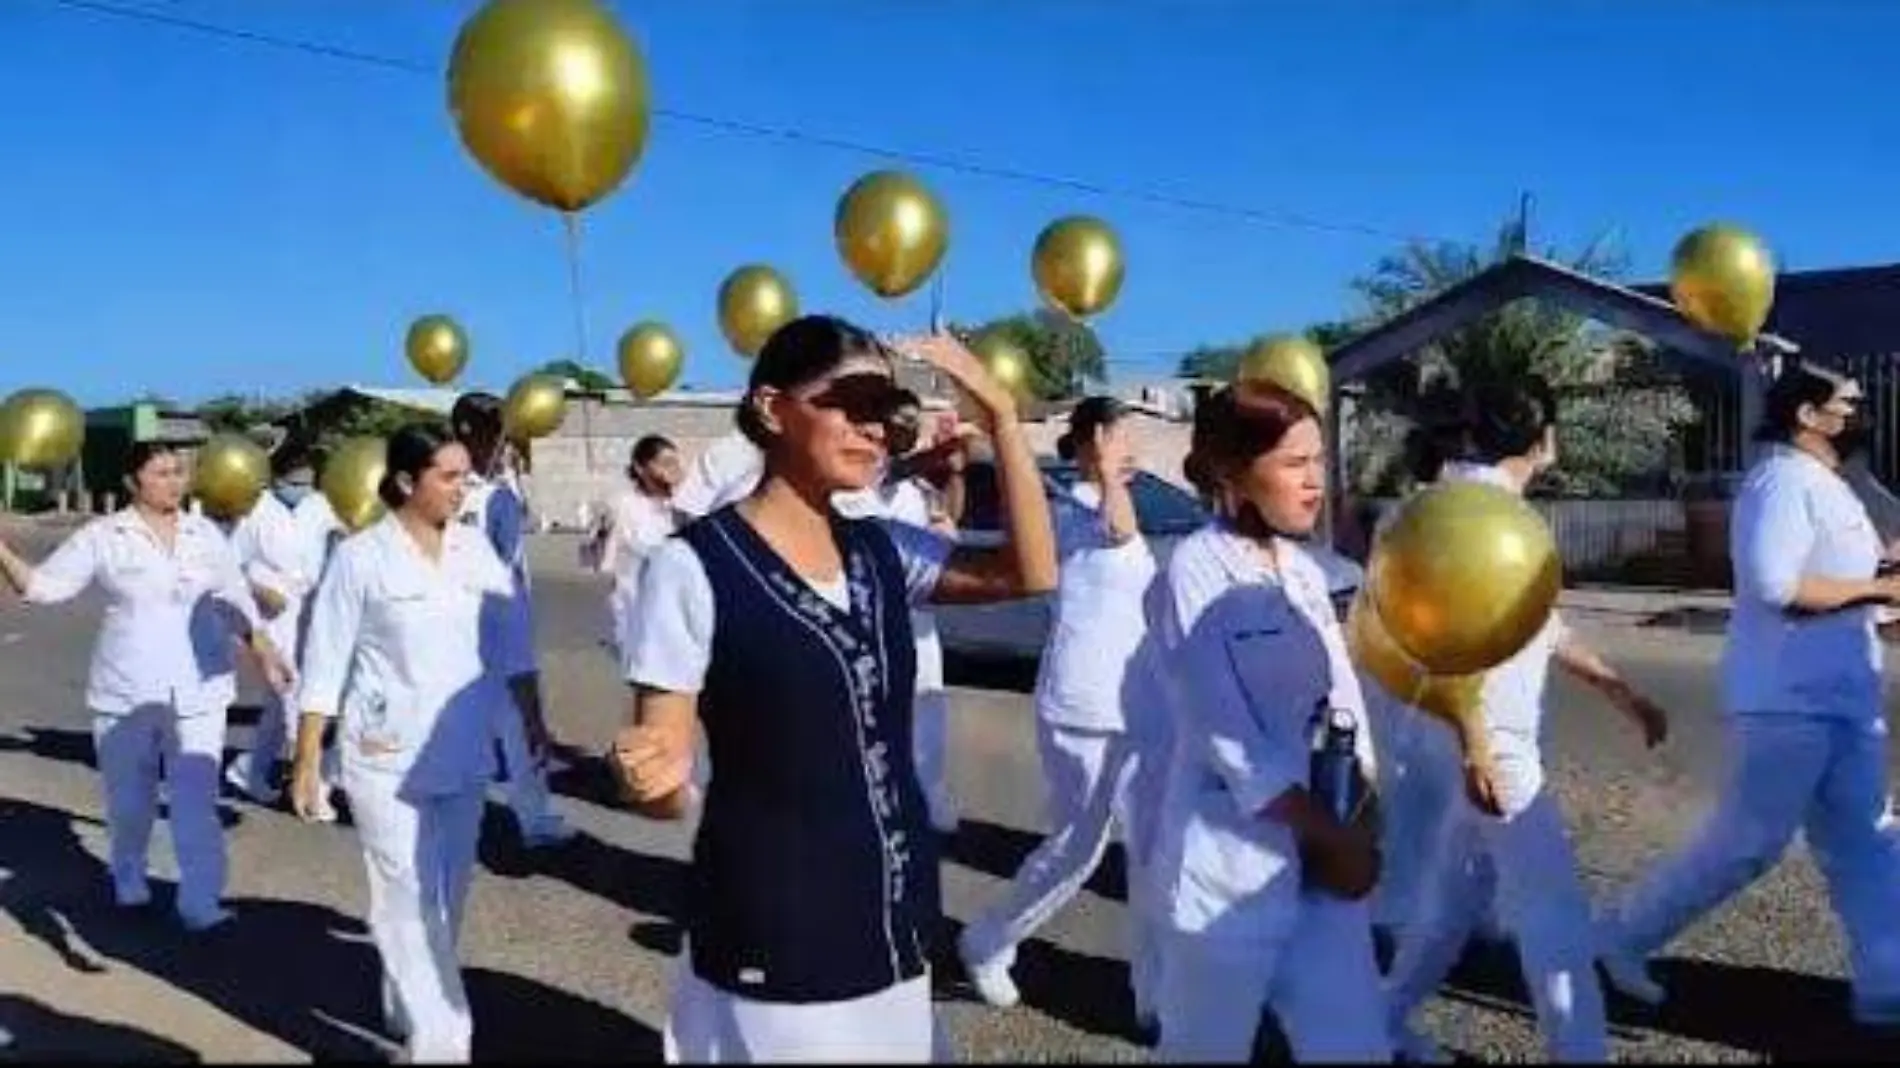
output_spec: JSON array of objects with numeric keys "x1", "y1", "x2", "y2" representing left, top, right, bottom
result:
[{"x1": 462, "y1": 475, "x2": 568, "y2": 844}]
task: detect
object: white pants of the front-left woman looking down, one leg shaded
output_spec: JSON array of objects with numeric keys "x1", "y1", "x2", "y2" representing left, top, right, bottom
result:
[{"x1": 344, "y1": 766, "x2": 483, "y2": 1064}]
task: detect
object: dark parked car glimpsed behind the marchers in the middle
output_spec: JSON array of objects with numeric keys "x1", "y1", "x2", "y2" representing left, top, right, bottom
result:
[{"x1": 933, "y1": 460, "x2": 1362, "y2": 661}]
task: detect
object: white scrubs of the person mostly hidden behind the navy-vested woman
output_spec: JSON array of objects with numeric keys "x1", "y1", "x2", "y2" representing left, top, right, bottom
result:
[{"x1": 832, "y1": 479, "x2": 958, "y2": 834}]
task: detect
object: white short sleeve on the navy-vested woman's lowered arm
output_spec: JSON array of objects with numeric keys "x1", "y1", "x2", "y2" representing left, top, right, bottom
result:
[{"x1": 621, "y1": 538, "x2": 713, "y2": 694}]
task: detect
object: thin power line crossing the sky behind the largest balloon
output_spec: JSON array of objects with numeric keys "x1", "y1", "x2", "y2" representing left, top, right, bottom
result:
[{"x1": 44, "y1": 0, "x2": 1450, "y2": 243}]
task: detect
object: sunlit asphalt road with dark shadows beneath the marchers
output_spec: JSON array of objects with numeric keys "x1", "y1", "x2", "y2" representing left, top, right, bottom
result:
[{"x1": 0, "y1": 528, "x2": 1900, "y2": 1060}]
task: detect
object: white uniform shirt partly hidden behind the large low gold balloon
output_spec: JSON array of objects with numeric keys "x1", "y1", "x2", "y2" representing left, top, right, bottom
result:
[{"x1": 1440, "y1": 462, "x2": 1569, "y2": 815}]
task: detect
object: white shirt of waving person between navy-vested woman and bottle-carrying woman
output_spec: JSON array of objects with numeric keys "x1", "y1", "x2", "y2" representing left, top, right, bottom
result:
[{"x1": 1036, "y1": 483, "x2": 1155, "y2": 732}]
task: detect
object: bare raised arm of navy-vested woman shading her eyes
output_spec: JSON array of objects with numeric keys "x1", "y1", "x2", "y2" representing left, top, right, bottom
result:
[{"x1": 912, "y1": 334, "x2": 1056, "y2": 604}]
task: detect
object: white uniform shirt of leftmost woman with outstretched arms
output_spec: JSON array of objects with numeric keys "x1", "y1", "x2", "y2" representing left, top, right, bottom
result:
[{"x1": 25, "y1": 507, "x2": 260, "y2": 716}]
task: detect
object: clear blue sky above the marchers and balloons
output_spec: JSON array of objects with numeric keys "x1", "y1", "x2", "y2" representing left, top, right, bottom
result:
[{"x1": 0, "y1": 0, "x2": 1900, "y2": 405}]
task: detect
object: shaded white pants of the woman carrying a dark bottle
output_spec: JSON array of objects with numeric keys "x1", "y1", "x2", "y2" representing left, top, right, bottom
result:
[{"x1": 1155, "y1": 891, "x2": 1393, "y2": 1064}]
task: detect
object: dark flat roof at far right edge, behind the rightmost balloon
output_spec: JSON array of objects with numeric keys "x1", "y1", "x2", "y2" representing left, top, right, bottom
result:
[{"x1": 1632, "y1": 264, "x2": 1900, "y2": 359}]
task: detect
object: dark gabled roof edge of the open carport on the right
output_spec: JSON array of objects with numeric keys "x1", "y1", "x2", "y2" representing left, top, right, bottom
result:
[{"x1": 1328, "y1": 257, "x2": 1801, "y2": 384}]
